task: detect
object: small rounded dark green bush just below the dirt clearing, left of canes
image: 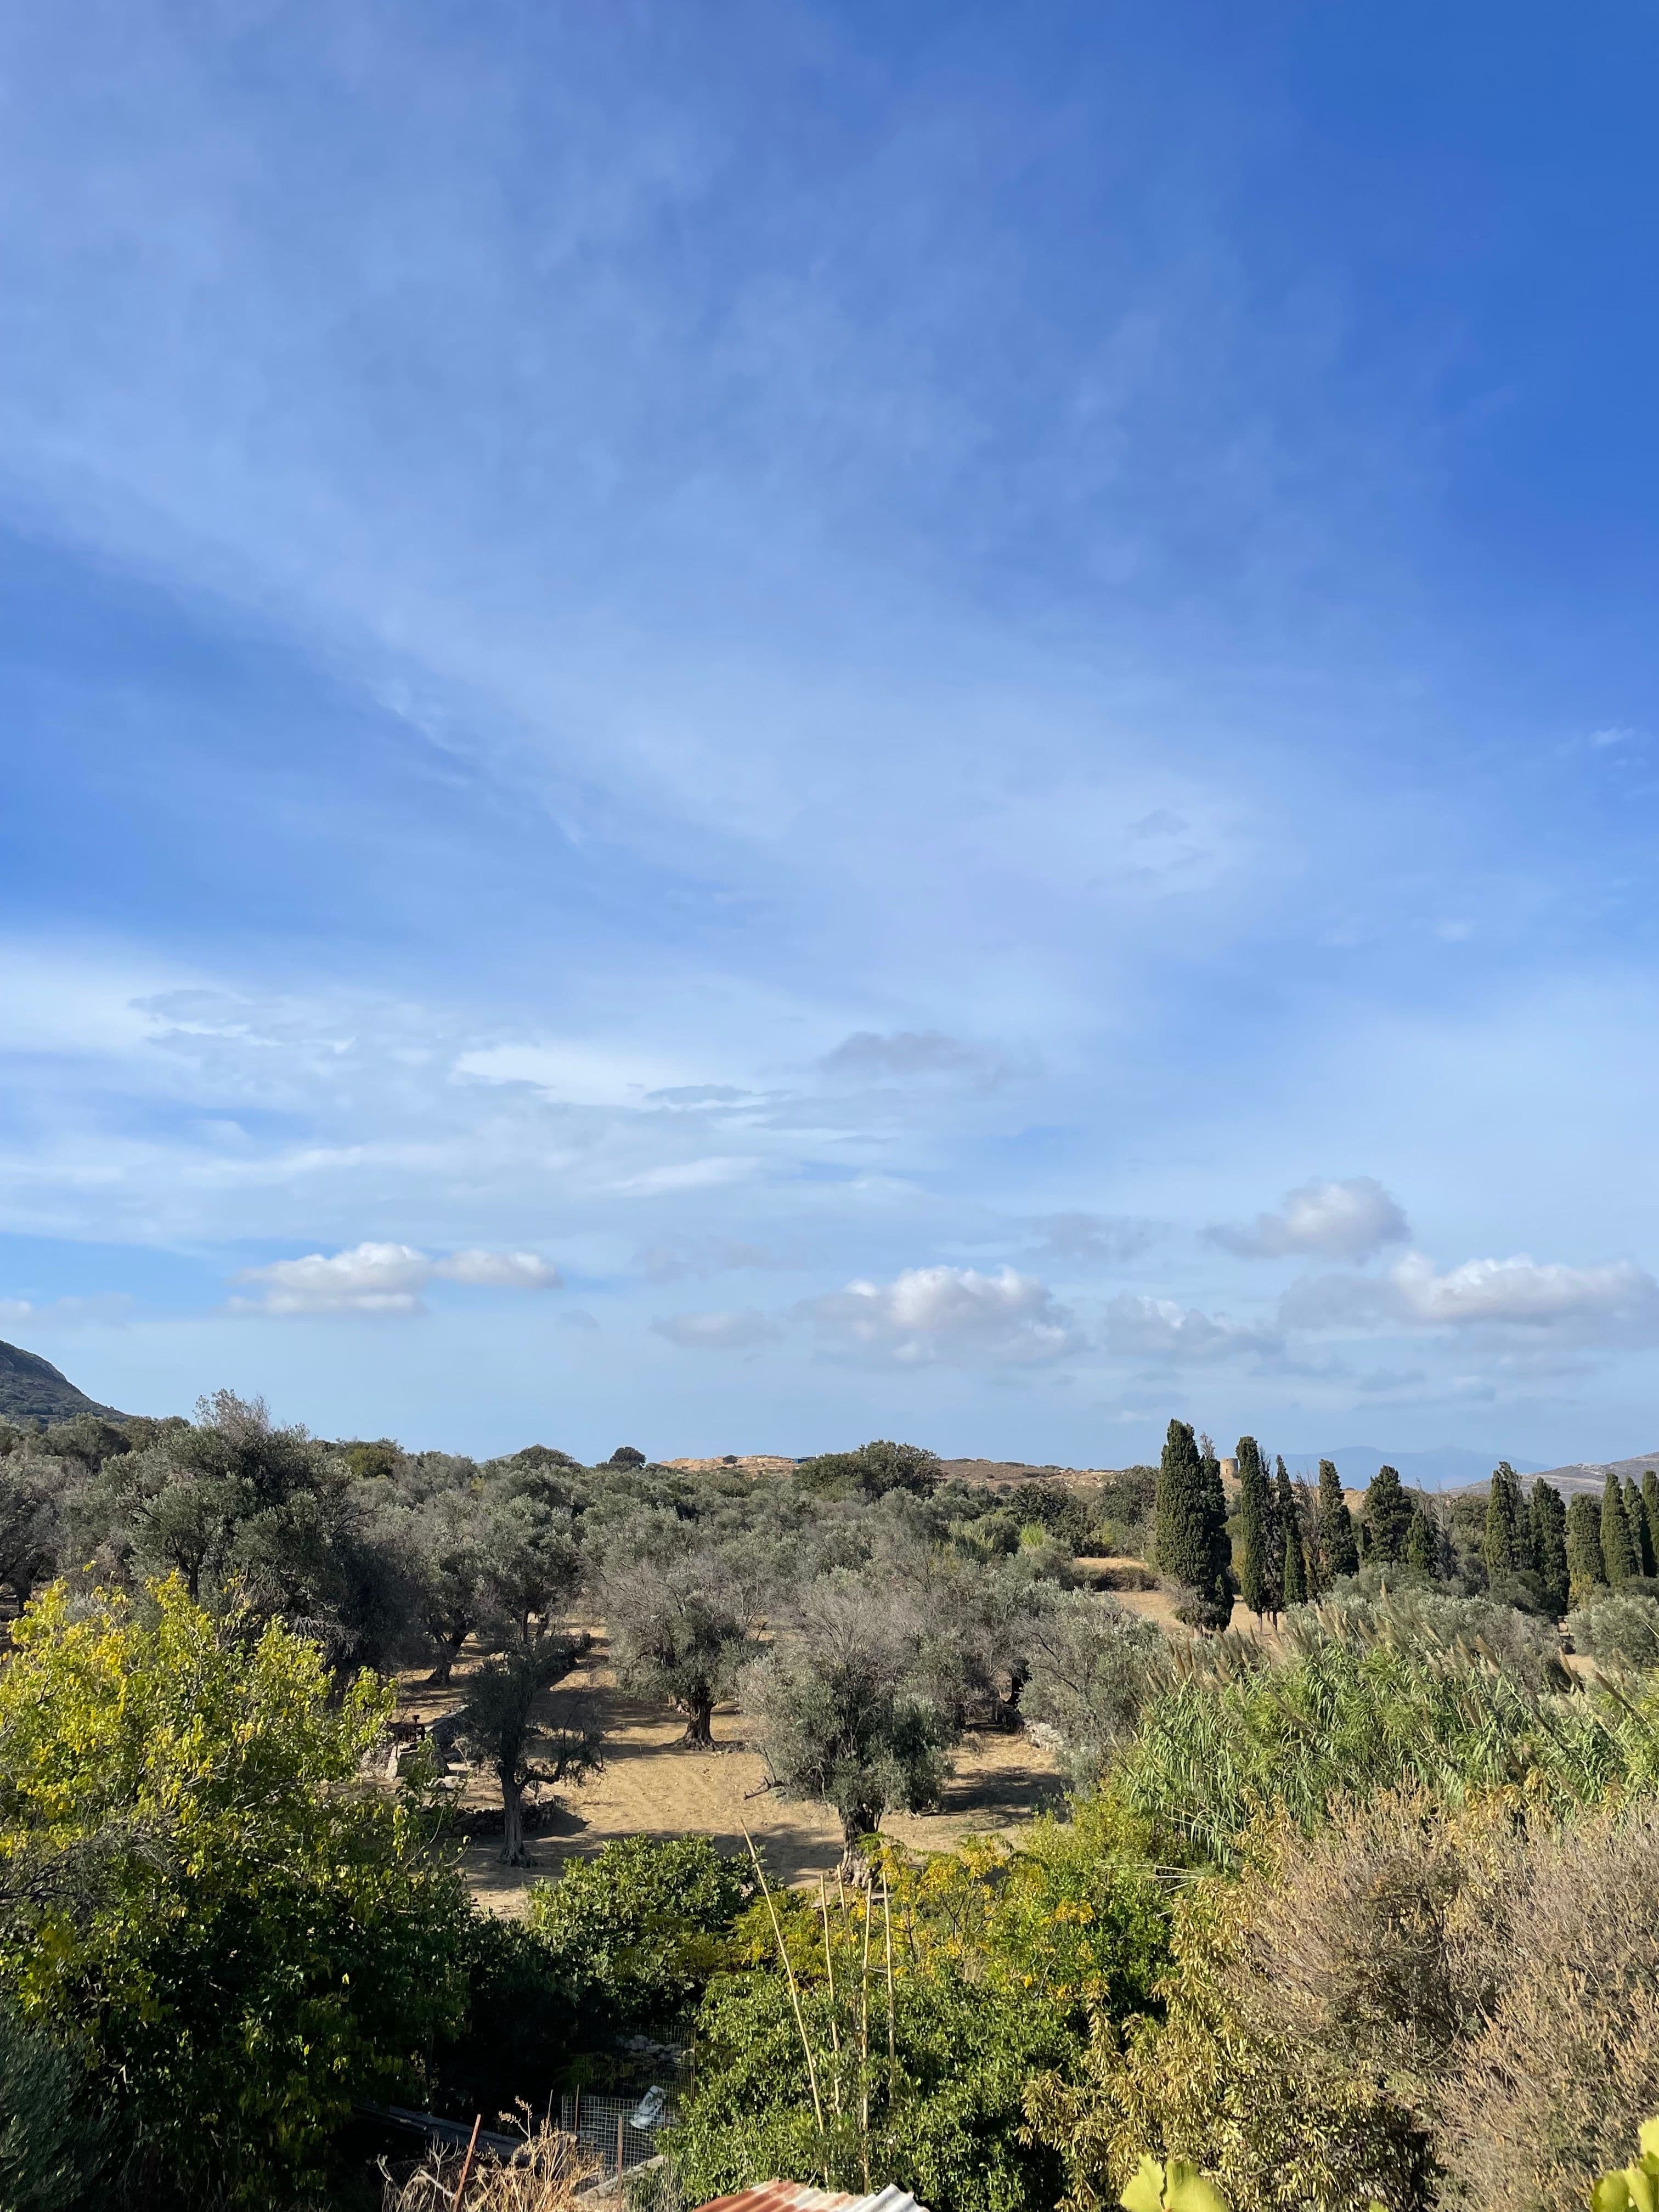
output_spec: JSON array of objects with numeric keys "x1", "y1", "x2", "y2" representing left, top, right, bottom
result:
[{"x1": 527, "y1": 1836, "x2": 752, "y2": 2035}]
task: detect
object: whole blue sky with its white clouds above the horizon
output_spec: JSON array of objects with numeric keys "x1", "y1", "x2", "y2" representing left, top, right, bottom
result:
[{"x1": 0, "y1": 0, "x2": 1659, "y2": 1464}]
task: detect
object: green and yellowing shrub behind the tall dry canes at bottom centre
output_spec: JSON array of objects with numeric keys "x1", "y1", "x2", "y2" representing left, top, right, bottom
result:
[{"x1": 668, "y1": 1803, "x2": 1166, "y2": 2212}]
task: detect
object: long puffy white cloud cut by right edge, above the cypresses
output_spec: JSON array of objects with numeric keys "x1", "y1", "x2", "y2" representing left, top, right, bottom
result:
[{"x1": 1278, "y1": 1252, "x2": 1659, "y2": 1340}]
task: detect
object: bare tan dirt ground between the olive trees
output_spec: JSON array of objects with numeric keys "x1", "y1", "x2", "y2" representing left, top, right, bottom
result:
[{"x1": 409, "y1": 1639, "x2": 1064, "y2": 1916}]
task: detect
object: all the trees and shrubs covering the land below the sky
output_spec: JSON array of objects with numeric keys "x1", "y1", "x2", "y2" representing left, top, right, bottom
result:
[{"x1": 0, "y1": 1396, "x2": 1659, "y2": 2212}]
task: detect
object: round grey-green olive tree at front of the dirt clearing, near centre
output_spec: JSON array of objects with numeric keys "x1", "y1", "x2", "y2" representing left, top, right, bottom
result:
[{"x1": 741, "y1": 1568, "x2": 956, "y2": 1876}]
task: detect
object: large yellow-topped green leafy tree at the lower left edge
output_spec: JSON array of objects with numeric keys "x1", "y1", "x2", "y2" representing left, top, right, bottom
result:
[{"x1": 0, "y1": 1579, "x2": 467, "y2": 2205}]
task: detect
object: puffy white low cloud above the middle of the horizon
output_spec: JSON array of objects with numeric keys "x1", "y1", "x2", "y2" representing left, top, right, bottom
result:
[{"x1": 801, "y1": 1267, "x2": 1082, "y2": 1367}]
